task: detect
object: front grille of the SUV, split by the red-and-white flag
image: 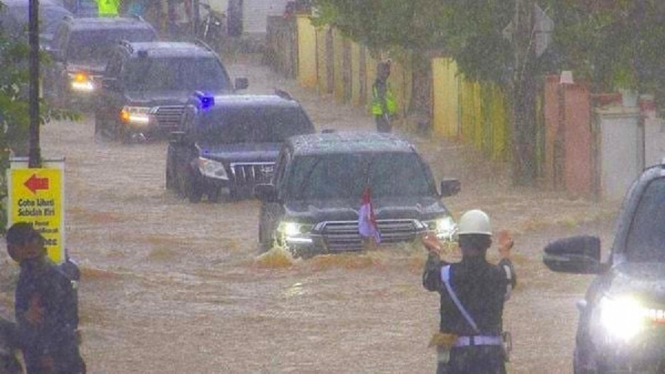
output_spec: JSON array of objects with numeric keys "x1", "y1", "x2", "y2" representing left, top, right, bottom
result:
[{"x1": 314, "y1": 219, "x2": 422, "y2": 251}]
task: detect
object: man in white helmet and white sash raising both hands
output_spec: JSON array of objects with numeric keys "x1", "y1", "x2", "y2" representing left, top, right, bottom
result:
[{"x1": 423, "y1": 210, "x2": 516, "y2": 374}]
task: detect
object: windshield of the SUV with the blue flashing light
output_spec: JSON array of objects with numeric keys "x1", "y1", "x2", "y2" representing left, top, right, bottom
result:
[{"x1": 197, "y1": 107, "x2": 314, "y2": 144}]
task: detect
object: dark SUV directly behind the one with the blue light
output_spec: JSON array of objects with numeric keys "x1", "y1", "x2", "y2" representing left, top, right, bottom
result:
[{"x1": 95, "y1": 41, "x2": 248, "y2": 142}]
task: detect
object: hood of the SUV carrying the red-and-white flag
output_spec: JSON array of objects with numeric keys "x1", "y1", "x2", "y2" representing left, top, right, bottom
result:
[{"x1": 285, "y1": 196, "x2": 449, "y2": 223}]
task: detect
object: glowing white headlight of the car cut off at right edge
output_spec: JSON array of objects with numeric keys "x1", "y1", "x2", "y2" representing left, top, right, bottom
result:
[{"x1": 599, "y1": 296, "x2": 646, "y2": 341}]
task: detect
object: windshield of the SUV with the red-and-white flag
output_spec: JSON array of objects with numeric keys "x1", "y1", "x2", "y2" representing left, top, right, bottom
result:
[{"x1": 286, "y1": 152, "x2": 432, "y2": 200}]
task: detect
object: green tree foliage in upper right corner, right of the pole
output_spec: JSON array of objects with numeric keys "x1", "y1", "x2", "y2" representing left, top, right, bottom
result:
[{"x1": 555, "y1": 0, "x2": 665, "y2": 93}]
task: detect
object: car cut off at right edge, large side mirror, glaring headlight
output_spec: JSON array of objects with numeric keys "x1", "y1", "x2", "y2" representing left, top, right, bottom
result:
[{"x1": 543, "y1": 164, "x2": 665, "y2": 373}]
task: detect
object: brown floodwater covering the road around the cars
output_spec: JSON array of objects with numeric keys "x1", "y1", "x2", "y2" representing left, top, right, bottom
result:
[{"x1": 0, "y1": 56, "x2": 615, "y2": 373}]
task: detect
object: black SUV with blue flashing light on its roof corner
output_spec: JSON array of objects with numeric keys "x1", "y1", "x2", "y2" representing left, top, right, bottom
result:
[{"x1": 166, "y1": 93, "x2": 314, "y2": 202}]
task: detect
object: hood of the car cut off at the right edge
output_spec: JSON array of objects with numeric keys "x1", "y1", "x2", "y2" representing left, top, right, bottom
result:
[{"x1": 608, "y1": 262, "x2": 665, "y2": 304}]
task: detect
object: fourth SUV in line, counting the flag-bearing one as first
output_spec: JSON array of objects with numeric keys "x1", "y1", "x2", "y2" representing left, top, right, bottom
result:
[{"x1": 44, "y1": 17, "x2": 158, "y2": 107}]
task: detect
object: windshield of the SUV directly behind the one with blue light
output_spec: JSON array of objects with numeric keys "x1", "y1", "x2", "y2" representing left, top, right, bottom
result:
[{"x1": 123, "y1": 57, "x2": 230, "y2": 93}]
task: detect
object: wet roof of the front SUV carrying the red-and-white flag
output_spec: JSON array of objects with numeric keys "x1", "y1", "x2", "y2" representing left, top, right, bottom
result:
[{"x1": 288, "y1": 131, "x2": 415, "y2": 155}]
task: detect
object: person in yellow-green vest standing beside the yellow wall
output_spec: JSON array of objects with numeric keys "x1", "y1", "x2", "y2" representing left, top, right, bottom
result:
[{"x1": 372, "y1": 61, "x2": 397, "y2": 132}]
